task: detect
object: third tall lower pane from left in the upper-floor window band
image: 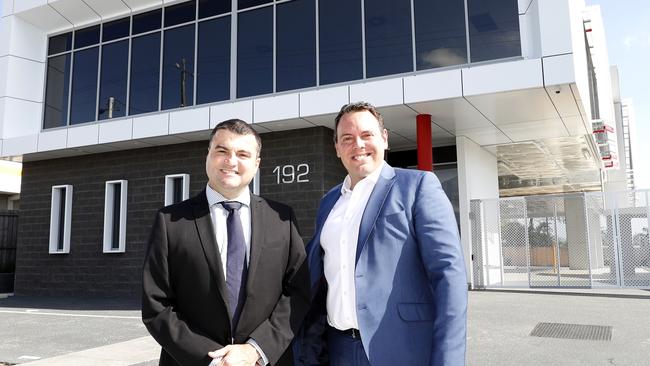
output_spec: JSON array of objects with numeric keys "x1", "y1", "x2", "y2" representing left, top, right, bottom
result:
[{"x1": 97, "y1": 40, "x2": 129, "y2": 119}]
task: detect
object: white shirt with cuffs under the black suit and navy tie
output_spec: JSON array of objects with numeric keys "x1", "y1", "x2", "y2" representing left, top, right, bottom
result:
[{"x1": 205, "y1": 184, "x2": 269, "y2": 366}]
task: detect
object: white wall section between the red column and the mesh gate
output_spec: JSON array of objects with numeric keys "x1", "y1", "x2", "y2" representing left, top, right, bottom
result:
[{"x1": 456, "y1": 136, "x2": 499, "y2": 280}]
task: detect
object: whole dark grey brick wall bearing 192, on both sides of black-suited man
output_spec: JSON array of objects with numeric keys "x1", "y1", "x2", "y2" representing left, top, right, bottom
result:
[{"x1": 15, "y1": 127, "x2": 345, "y2": 297}]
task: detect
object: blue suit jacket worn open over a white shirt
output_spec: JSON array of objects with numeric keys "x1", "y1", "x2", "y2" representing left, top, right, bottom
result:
[{"x1": 294, "y1": 164, "x2": 467, "y2": 366}]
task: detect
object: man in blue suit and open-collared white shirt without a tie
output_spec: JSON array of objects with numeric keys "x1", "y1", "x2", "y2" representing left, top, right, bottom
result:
[{"x1": 294, "y1": 102, "x2": 467, "y2": 366}]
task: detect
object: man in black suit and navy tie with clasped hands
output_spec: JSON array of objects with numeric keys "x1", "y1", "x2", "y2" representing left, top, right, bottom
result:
[{"x1": 142, "y1": 120, "x2": 310, "y2": 366}]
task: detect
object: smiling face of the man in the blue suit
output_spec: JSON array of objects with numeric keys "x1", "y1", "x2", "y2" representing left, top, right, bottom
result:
[{"x1": 334, "y1": 110, "x2": 388, "y2": 188}]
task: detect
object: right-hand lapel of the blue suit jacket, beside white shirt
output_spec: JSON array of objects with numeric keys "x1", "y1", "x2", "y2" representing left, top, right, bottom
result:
[{"x1": 355, "y1": 164, "x2": 395, "y2": 263}]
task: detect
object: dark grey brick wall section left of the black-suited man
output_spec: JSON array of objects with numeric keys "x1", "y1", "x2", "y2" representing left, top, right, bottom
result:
[{"x1": 15, "y1": 142, "x2": 207, "y2": 296}]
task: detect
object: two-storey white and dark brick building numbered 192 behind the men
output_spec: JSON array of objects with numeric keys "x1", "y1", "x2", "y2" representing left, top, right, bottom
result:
[{"x1": 0, "y1": 0, "x2": 628, "y2": 296}]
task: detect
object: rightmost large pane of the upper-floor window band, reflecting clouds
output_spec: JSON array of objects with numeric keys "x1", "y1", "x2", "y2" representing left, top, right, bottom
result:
[{"x1": 467, "y1": 0, "x2": 521, "y2": 62}]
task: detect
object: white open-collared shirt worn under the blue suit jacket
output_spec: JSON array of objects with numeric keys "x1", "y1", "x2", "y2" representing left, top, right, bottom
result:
[{"x1": 320, "y1": 163, "x2": 385, "y2": 330}]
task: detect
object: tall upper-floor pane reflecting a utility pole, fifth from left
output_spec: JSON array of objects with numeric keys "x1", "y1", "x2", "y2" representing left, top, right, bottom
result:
[{"x1": 162, "y1": 24, "x2": 194, "y2": 109}]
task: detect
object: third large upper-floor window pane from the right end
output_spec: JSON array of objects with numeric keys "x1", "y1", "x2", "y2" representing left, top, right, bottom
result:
[{"x1": 365, "y1": 0, "x2": 413, "y2": 78}]
